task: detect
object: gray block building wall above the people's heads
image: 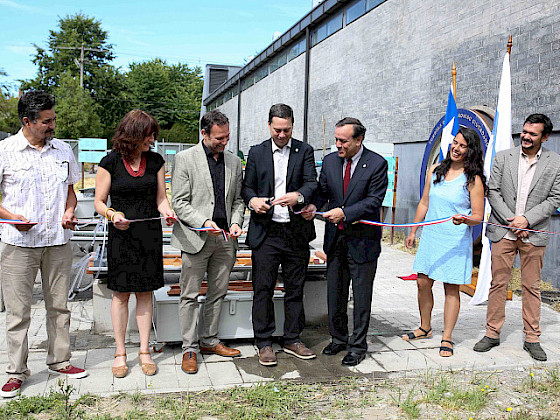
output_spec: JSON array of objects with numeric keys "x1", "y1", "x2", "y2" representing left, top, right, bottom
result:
[{"x1": 215, "y1": 0, "x2": 560, "y2": 151}]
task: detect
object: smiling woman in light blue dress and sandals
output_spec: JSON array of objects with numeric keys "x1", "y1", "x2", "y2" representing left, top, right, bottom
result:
[{"x1": 402, "y1": 128, "x2": 487, "y2": 357}]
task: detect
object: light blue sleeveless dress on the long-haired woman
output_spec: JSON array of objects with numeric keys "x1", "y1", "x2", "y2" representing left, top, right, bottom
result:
[{"x1": 413, "y1": 173, "x2": 472, "y2": 284}]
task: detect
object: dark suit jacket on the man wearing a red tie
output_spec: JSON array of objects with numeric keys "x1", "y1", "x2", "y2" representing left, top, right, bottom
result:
[{"x1": 315, "y1": 147, "x2": 388, "y2": 264}]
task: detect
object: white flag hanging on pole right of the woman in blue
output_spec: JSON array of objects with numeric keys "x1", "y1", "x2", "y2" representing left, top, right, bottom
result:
[{"x1": 469, "y1": 53, "x2": 513, "y2": 305}]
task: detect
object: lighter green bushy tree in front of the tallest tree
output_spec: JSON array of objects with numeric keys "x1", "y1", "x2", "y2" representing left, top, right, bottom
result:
[{"x1": 54, "y1": 72, "x2": 103, "y2": 139}]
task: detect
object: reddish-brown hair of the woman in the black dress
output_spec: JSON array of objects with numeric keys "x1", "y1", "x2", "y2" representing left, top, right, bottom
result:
[{"x1": 113, "y1": 109, "x2": 159, "y2": 162}]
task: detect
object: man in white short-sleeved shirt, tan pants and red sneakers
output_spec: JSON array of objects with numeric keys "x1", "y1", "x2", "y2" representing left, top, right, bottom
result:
[{"x1": 0, "y1": 91, "x2": 88, "y2": 398}]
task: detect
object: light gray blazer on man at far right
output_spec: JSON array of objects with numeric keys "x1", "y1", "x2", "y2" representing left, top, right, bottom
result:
[{"x1": 486, "y1": 146, "x2": 560, "y2": 246}]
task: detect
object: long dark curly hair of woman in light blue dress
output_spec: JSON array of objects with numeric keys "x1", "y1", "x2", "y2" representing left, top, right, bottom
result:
[{"x1": 434, "y1": 127, "x2": 488, "y2": 195}]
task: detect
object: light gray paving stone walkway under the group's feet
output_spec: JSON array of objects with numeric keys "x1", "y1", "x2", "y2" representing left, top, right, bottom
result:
[{"x1": 0, "y1": 238, "x2": 560, "y2": 396}]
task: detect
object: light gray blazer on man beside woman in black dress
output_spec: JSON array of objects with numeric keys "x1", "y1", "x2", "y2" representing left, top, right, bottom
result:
[{"x1": 171, "y1": 143, "x2": 245, "y2": 254}]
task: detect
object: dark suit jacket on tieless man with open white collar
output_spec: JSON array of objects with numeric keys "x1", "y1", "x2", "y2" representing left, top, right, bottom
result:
[{"x1": 241, "y1": 139, "x2": 317, "y2": 249}]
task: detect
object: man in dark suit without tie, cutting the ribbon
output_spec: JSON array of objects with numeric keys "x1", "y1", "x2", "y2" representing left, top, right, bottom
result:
[{"x1": 241, "y1": 104, "x2": 317, "y2": 366}]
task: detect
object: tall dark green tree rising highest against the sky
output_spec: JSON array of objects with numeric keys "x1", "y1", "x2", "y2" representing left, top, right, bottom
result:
[{"x1": 22, "y1": 13, "x2": 114, "y2": 93}]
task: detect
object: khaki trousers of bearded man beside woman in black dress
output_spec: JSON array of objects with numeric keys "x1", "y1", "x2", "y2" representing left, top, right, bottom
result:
[{"x1": 179, "y1": 235, "x2": 235, "y2": 353}]
